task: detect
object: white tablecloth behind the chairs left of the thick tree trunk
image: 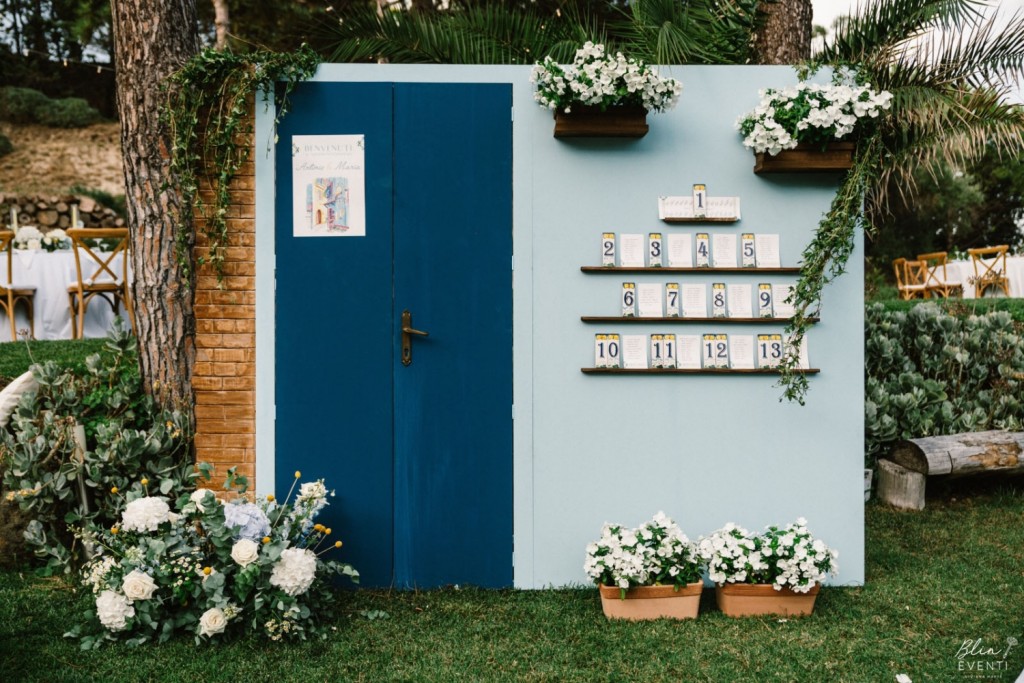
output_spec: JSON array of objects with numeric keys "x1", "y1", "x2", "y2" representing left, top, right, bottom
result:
[{"x1": 0, "y1": 249, "x2": 128, "y2": 341}]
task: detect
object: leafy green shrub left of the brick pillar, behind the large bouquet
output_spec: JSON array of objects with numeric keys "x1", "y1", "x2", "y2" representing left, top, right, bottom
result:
[{"x1": 0, "y1": 321, "x2": 197, "y2": 574}]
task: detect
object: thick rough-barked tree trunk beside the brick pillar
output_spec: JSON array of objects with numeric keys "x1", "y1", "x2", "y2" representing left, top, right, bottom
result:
[{"x1": 111, "y1": 0, "x2": 200, "y2": 410}]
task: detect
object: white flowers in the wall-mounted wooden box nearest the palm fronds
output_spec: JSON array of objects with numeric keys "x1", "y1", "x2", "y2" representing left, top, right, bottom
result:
[{"x1": 736, "y1": 81, "x2": 893, "y2": 155}]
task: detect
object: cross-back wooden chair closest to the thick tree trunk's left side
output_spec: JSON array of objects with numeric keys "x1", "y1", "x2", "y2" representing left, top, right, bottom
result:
[{"x1": 68, "y1": 227, "x2": 135, "y2": 339}]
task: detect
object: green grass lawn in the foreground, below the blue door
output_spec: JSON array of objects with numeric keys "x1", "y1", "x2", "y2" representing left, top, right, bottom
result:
[{"x1": 0, "y1": 484, "x2": 1024, "y2": 683}]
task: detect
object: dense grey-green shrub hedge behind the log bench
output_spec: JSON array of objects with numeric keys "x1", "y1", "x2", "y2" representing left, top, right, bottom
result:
[{"x1": 864, "y1": 304, "x2": 1024, "y2": 461}]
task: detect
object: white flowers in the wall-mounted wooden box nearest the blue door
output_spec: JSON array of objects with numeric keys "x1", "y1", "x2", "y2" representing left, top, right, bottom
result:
[{"x1": 529, "y1": 41, "x2": 683, "y2": 114}]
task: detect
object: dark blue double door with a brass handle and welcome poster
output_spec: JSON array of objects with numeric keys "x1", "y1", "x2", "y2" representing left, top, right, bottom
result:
[{"x1": 275, "y1": 83, "x2": 513, "y2": 588}]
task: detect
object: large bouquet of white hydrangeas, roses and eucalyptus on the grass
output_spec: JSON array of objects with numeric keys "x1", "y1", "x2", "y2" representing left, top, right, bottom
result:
[{"x1": 67, "y1": 472, "x2": 358, "y2": 649}]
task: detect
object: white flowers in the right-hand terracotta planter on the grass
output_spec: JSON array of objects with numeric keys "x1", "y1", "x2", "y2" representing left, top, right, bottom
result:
[{"x1": 697, "y1": 517, "x2": 839, "y2": 593}]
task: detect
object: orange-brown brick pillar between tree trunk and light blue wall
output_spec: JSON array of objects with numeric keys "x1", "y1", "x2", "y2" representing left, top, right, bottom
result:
[{"x1": 193, "y1": 118, "x2": 256, "y2": 489}]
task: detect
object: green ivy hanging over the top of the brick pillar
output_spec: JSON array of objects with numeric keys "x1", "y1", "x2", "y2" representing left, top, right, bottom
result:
[{"x1": 163, "y1": 45, "x2": 321, "y2": 283}]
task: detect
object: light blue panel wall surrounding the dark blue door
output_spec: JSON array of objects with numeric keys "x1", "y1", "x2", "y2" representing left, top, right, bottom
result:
[{"x1": 249, "y1": 65, "x2": 864, "y2": 588}]
